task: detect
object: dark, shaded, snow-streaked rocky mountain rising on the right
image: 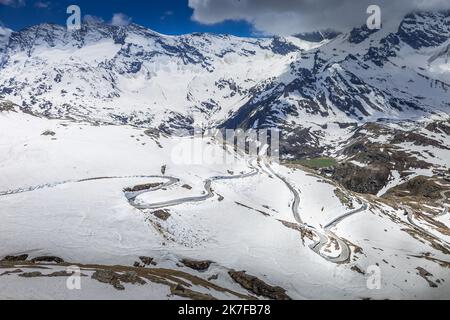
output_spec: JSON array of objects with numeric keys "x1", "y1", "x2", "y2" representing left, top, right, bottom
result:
[{"x1": 226, "y1": 12, "x2": 450, "y2": 127}]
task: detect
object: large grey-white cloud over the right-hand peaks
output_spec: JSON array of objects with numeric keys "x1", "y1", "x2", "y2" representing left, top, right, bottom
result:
[{"x1": 189, "y1": 0, "x2": 450, "y2": 35}]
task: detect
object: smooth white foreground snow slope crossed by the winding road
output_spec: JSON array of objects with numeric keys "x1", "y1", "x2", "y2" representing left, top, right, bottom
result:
[{"x1": 0, "y1": 108, "x2": 450, "y2": 299}]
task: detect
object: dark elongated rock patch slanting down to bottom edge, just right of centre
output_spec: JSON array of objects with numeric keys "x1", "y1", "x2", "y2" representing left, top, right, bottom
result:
[{"x1": 228, "y1": 270, "x2": 292, "y2": 300}]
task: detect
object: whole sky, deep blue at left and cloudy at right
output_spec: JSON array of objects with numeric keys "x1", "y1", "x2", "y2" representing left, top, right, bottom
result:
[{"x1": 0, "y1": 0, "x2": 450, "y2": 36}]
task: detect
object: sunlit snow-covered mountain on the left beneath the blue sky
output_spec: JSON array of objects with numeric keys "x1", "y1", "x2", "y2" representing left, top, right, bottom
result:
[{"x1": 0, "y1": 24, "x2": 310, "y2": 131}]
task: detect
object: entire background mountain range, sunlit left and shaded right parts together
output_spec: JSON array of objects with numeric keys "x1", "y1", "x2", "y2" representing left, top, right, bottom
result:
[{"x1": 0, "y1": 12, "x2": 450, "y2": 132}]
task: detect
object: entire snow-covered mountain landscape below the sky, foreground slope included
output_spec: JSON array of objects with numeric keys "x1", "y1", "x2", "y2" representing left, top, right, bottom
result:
[{"x1": 0, "y1": 12, "x2": 450, "y2": 299}]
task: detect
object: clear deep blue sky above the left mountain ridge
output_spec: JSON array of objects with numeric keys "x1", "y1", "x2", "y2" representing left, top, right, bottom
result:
[{"x1": 0, "y1": 0, "x2": 253, "y2": 36}]
